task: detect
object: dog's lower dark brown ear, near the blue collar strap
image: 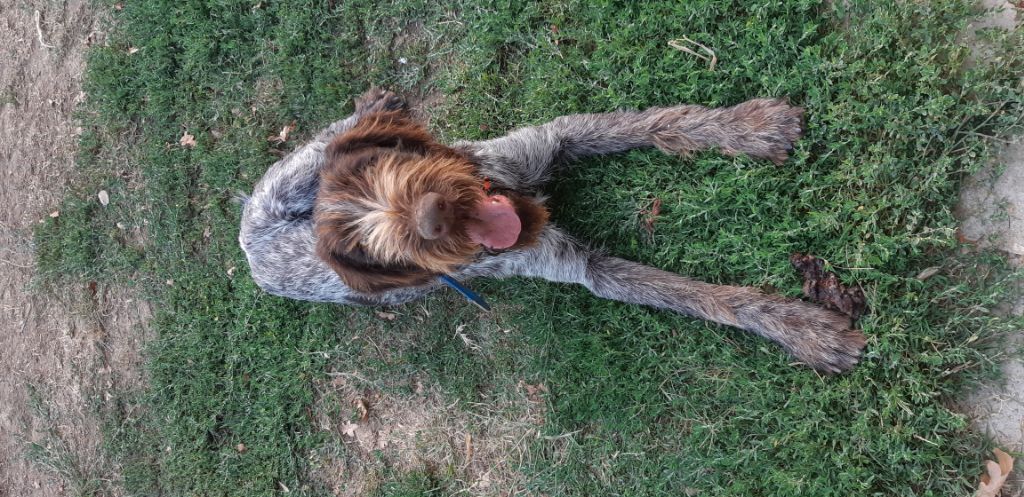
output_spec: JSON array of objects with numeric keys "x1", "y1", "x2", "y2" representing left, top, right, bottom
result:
[{"x1": 316, "y1": 215, "x2": 436, "y2": 293}]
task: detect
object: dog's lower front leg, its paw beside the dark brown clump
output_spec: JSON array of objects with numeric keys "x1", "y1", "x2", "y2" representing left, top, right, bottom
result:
[{"x1": 487, "y1": 227, "x2": 865, "y2": 373}]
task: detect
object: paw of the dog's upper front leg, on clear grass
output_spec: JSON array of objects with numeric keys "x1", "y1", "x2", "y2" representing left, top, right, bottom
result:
[{"x1": 722, "y1": 98, "x2": 804, "y2": 164}]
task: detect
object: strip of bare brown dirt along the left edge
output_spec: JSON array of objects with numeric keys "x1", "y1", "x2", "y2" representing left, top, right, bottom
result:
[{"x1": 0, "y1": 0, "x2": 150, "y2": 496}]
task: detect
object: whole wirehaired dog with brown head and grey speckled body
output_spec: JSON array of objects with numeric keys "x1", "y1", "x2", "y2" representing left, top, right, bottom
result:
[{"x1": 239, "y1": 90, "x2": 864, "y2": 372}]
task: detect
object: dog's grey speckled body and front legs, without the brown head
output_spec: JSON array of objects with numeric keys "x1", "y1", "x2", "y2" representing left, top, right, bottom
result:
[{"x1": 239, "y1": 90, "x2": 864, "y2": 372}]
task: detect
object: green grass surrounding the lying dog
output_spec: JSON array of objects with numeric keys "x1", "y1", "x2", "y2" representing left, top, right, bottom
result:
[{"x1": 37, "y1": 0, "x2": 1024, "y2": 496}]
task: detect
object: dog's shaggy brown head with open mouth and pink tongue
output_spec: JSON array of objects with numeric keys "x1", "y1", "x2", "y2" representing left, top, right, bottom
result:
[{"x1": 314, "y1": 111, "x2": 547, "y2": 292}]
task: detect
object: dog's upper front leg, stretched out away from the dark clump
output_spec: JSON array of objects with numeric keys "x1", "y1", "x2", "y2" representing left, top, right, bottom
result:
[{"x1": 455, "y1": 98, "x2": 803, "y2": 190}]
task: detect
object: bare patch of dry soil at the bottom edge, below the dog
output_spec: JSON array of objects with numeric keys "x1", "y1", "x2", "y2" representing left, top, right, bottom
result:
[{"x1": 312, "y1": 373, "x2": 547, "y2": 497}]
